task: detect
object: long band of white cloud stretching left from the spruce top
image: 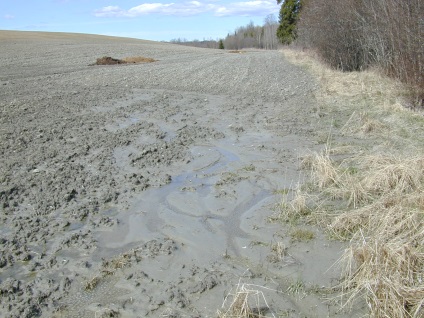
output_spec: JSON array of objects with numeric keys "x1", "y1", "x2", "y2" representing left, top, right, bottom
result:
[{"x1": 94, "y1": 0, "x2": 279, "y2": 17}]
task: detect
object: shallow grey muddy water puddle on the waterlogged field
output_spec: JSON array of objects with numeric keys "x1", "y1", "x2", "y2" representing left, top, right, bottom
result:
[{"x1": 99, "y1": 146, "x2": 271, "y2": 254}]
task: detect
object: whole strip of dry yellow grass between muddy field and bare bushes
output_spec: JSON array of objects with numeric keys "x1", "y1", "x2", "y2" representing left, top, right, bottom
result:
[{"x1": 284, "y1": 51, "x2": 424, "y2": 317}]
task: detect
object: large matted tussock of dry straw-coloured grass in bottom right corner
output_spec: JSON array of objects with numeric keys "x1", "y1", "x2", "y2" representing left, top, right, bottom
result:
[{"x1": 341, "y1": 207, "x2": 424, "y2": 317}]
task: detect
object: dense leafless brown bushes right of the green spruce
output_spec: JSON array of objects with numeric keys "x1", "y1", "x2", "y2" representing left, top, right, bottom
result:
[{"x1": 298, "y1": 0, "x2": 424, "y2": 106}]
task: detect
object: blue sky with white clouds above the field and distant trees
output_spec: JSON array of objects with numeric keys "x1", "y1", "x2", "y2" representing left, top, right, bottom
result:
[{"x1": 0, "y1": 0, "x2": 279, "y2": 41}]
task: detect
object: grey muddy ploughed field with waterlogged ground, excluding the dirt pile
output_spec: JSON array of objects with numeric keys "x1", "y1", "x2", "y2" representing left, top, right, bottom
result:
[{"x1": 0, "y1": 31, "x2": 360, "y2": 317}]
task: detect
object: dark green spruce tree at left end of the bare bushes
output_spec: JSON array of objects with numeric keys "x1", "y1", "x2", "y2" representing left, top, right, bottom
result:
[{"x1": 277, "y1": 0, "x2": 302, "y2": 44}]
